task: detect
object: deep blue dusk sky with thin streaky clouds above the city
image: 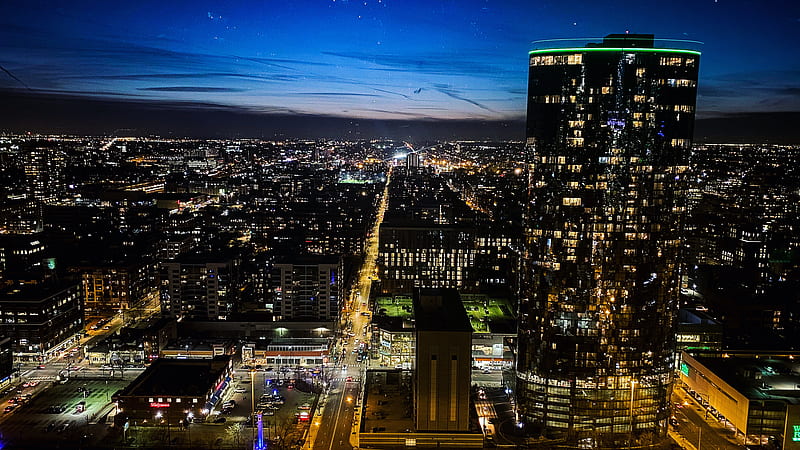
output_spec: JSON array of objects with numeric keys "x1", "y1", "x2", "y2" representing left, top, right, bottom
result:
[{"x1": 0, "y1": 0, "x2": 800, "y2": 139}]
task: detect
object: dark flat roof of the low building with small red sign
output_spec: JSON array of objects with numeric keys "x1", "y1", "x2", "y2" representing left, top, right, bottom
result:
[{"x1": 122, "y1": 357, "x2": 230, "y2": 397}]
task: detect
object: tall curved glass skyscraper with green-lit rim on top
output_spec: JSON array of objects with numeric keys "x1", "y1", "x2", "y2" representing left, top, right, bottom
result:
[{"x1": 517, "y1": 35, "x2": 700, "y2": 448}]
